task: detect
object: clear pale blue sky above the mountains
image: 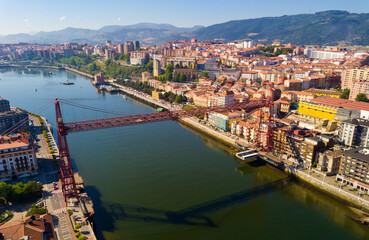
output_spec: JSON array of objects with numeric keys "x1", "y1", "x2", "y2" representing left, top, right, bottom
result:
[{"x1": 0, "y1": 0, "x2": 369, "y2": 35}]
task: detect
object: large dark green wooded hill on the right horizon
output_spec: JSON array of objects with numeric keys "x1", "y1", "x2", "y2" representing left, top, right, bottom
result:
[{"x1": 192, "y1": 10, "x2": 369, "y2": 45}]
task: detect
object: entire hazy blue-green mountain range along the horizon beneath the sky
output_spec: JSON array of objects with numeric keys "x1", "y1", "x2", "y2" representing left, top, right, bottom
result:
[{"x1": 0, "y1": 10, "x2": 369, "y2": 45}]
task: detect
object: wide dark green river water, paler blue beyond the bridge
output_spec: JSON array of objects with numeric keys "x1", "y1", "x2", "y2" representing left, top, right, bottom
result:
[{"x1": 0, "y1": 69, "x2": 369, "y2": 240}]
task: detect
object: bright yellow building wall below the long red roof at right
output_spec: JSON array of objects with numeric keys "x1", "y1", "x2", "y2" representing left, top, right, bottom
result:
[{"x1": 298, "y1": 102, "x2": 337, "y2": 121}]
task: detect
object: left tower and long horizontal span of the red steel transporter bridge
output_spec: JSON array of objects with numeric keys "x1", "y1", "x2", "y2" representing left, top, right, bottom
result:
[{"x1": 55, "y1": 99, "x2": 273, "y2": 199}]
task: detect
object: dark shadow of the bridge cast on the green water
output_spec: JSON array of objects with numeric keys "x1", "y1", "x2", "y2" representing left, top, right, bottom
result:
[{"x1": 86, "y1": 178, "x2": 291, "y2": 239}]
